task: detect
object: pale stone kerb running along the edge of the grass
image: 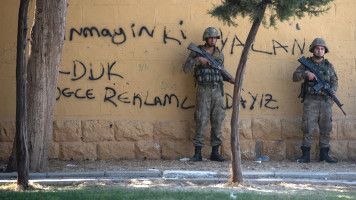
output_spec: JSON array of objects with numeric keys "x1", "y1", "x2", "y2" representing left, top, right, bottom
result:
[{"x1": 0, "y1": 169, "x2": 356, "y2": 186}]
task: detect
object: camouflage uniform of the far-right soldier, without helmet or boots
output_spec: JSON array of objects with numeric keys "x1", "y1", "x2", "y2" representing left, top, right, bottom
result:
[{"x1": 293, "y1": 58, "x2": 338, "y2": 148}]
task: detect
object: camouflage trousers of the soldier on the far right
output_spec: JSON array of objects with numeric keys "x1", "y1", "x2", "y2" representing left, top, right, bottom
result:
[{"x1": 302, "y1": 95, "x2": 333, "y2": 148}]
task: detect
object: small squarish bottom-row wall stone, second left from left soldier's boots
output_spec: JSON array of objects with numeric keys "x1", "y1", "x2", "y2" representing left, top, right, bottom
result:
[{"x1": 135, "y1": 141, "x2": 161, "y2": 159}]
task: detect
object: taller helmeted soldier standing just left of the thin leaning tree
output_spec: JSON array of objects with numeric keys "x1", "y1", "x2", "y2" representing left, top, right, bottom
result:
[{"x1": 183, "y1": 27, "x2": 235, "y2": 162}]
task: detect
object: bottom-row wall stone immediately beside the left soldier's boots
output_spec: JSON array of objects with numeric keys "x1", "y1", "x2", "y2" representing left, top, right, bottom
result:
[{"x1": 160, "y1": 140, "x2": 191, "y2": 159}]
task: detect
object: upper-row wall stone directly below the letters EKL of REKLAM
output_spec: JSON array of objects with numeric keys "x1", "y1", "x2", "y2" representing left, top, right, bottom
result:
[{"x1": 115, "y1": 120, "x2": 154, "y2": 141}]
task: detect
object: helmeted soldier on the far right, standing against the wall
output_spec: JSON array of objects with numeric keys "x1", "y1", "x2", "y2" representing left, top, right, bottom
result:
[{"x1": 293, "y1": 38, "x2": 338, "y2": 163}]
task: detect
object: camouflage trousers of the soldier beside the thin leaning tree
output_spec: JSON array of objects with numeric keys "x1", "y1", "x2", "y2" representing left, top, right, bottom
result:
[{"x1": 193, "y1": 85, "x2": 225, "y2": 146}]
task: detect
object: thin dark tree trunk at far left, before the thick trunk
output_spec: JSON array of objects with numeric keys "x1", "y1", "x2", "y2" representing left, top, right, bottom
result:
[{"x1": 15, "y1": 0, "x2": 29, "y2": 189}]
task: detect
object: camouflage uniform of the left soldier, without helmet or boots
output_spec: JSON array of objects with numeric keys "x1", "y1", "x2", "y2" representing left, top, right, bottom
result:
[{"x1": 183, "y1": 45, "x2": 225, "y2": 146}]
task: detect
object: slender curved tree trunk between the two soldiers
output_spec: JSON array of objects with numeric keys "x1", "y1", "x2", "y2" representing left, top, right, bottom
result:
[{"x1": 231, "y1": 4, "x2": 266, "y2": 183}]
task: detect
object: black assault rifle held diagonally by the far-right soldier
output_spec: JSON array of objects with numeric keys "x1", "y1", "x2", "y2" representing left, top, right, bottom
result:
[{"x1": 298, "y1": 56, "x2": 346, "y2": 116}]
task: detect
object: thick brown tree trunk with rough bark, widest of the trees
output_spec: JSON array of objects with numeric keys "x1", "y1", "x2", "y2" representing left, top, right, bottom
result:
[{"x1": 27, "y1": 0, "x2": 67, "y2": 171}]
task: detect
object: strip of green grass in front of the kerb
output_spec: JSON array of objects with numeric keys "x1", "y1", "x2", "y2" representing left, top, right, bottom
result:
[{"x1": 0, "y1": 185, "x2": 356, "y2": 200}]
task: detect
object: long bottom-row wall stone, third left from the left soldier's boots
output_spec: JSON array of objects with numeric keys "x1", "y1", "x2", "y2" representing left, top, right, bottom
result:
[{"x1": 98, "y1": 141, "x2": 135, "y2": 160}]
